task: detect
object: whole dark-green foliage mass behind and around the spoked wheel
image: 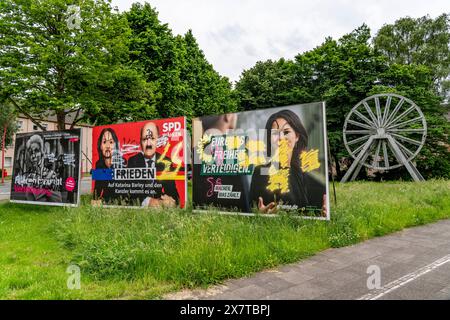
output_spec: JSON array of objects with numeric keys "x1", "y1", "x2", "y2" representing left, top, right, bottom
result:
[{"x1": 236, "y1": 25, "x2": 450, "y2": 179}]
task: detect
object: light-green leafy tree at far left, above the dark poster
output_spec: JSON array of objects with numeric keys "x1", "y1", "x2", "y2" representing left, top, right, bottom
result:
[{"x1": 0, "y1": 0, "x2": 155, "y2": 130}]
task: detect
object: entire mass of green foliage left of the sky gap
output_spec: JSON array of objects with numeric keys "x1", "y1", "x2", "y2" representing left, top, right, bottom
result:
[{"x1": 0, "y1": 0, "x2": 237, "y2": 128}]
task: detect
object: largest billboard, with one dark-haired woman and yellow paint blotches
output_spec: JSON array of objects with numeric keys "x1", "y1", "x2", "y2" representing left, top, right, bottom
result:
[{"x1": 192, "y1": 102, "x2": 330, "y2": 219}]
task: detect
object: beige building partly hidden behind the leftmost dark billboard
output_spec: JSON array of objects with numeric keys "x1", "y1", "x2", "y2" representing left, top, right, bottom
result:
[{"x1": 0, "y1": 114, "x2": 92, "y2": 176}]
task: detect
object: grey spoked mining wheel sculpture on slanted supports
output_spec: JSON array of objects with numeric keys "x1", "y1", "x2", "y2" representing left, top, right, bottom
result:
[{"x1": 341, "y1": 93, "x2": 427, "y2": 182}]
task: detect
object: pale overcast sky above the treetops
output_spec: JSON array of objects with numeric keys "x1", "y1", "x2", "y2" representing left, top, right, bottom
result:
[{"x1": 112, "y1": 0, "x2": 450, "y2": 81}]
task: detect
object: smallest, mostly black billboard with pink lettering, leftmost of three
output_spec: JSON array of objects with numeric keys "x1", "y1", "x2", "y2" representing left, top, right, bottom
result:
[{"x1": 10, "y1": 129, "x2": 81, "y2": 206}]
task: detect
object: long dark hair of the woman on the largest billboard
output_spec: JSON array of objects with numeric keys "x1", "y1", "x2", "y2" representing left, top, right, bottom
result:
[{"x1": 266, "y1": 110, "x2": 308, "y2": 169}]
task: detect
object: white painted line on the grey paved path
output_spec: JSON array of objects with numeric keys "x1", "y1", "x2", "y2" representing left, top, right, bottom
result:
[{"x1": 358, "y1": 254, "x2": 450, "y2": 300}]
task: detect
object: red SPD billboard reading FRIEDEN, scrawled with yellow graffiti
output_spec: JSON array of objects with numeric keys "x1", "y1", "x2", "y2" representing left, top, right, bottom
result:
[{"x1": 92, "y1": 117, "x2": 187, "y2": 208}]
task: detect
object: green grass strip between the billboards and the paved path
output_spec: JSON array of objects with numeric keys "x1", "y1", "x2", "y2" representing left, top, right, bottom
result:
[{"x1": 0, "y1": 180, "x2": 450, "y2": 299}]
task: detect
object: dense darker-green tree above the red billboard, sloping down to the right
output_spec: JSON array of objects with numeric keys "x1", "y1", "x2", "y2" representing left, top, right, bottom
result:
[{"x1": 124, "y1": 3, "x2": 236, "y2": 124}]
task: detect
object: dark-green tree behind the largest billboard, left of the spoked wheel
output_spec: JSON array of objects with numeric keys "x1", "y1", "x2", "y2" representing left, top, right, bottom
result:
[{"x1": 236, "y1": 25, "x2": 385, "y2": 176}]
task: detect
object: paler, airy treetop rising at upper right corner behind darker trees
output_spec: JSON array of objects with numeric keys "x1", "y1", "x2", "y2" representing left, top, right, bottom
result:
[{"x1": 373, "y1": 14, "x2": 450, "y2": 97}]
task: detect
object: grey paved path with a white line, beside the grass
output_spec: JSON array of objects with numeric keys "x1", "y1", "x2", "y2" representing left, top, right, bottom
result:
[{"x1": 165, "y1": 220, "x2": 450, "y2": 300}]
